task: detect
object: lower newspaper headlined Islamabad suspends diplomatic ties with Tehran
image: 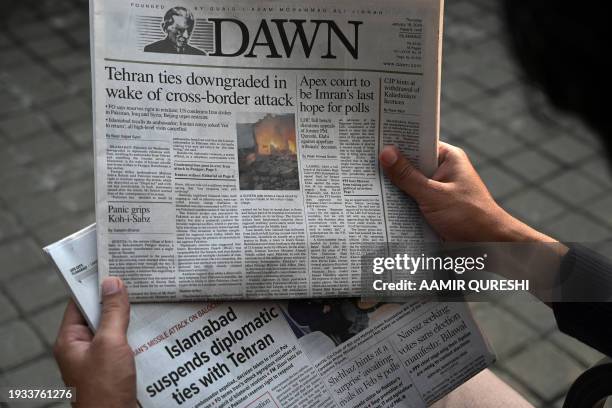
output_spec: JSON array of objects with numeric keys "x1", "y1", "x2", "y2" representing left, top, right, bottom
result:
[{"x1": 45, "y1": 225, "x2": 494, "y2": 408}]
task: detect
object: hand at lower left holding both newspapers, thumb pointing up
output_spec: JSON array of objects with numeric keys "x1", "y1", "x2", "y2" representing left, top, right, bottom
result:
[{"x1": 54, "y1": 277, "x2": 136, "y2": 408}]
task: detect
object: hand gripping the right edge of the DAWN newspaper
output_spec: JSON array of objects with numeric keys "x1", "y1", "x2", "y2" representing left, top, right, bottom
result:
[{"x1": 380, "y1": 142, "x2": 554, "y2": 242}]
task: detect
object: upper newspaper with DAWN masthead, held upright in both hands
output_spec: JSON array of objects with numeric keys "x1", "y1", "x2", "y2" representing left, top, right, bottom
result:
[{"x1": 91, "y1": 0, "x2": 442, "y2": 301}]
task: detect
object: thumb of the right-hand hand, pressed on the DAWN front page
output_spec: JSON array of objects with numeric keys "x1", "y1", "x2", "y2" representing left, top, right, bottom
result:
[{"x1": 380, "y1": 146, "x2": 435, "y2": 202}]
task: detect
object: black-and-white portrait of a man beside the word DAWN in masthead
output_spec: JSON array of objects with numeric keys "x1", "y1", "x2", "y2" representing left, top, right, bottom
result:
[{"x1": 144, "y1": 7, "x2": 206, "y2": 55}]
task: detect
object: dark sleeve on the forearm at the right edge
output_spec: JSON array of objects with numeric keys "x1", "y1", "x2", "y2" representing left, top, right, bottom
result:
[{"x1": 553, "y1": 245, "x2": 612, "y2": 356}]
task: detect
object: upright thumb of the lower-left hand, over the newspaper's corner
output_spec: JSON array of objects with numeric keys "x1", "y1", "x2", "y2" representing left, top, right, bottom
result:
[{"x1": 96, "y1": 277, "x2": 130, "y2": 341}]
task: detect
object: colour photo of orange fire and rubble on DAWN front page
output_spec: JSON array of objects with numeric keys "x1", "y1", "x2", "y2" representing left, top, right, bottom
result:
[{"x1": 236, "y1": 112, "x2": 300, "y2": 190}]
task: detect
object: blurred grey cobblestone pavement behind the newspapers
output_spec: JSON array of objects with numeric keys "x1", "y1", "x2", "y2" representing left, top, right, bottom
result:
[{"x1": 0, "y1": 0, "x2": 612, "y2": 407}]
